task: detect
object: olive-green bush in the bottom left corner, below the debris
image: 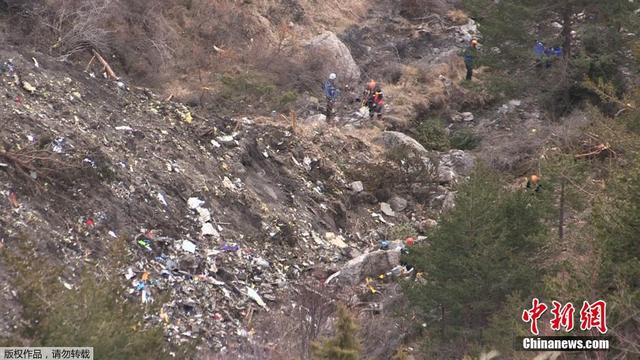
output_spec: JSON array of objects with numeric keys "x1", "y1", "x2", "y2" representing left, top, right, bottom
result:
[{"x1": 0, "y1": 241, "x2": 179, "y2": 359}]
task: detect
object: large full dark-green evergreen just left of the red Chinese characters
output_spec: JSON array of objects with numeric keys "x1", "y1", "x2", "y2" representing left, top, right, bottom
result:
[{"x1": 406, "y1": 169, "x2": 546, "y2": 352}]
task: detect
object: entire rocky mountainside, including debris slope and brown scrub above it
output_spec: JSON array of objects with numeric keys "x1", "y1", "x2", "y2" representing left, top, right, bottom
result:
[{"x1": 0, "y1": 0, "x2": 622, "y2": 360}]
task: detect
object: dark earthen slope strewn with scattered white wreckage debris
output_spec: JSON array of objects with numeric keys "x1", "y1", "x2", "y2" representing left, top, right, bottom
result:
[{"x1": 0, "y1": 41, "x2": 473, "y2": 351}]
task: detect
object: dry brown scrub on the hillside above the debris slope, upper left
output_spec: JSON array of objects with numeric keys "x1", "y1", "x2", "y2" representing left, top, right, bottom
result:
[{"x1": 0, "y1": 0, "x2": 368, "y2": 111}]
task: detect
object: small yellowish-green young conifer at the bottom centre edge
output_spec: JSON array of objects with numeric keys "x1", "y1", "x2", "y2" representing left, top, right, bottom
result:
[{"x1": 311, "y1": 306, "x2": 360, "y2": 360}]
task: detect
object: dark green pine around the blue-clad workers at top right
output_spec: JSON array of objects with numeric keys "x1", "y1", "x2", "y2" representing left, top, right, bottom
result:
[{"x1": 464, "y1": 0, "x2": 640, "y2": 114}]
